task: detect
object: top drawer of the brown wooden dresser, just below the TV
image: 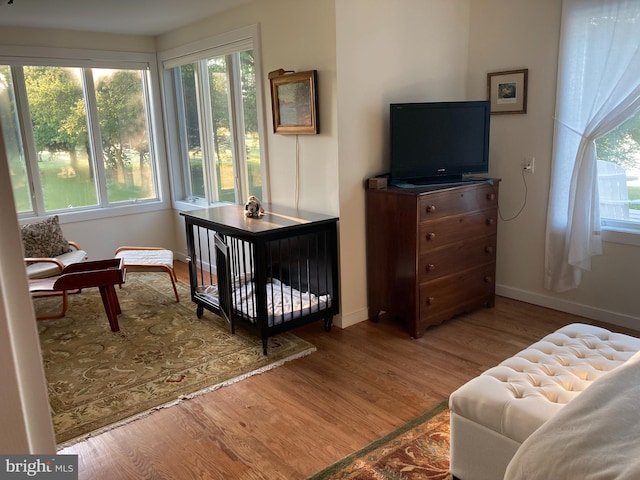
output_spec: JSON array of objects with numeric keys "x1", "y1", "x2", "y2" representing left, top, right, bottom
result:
[{"x1": 419, "y1": 185, "x2": 498, "y2": 222}]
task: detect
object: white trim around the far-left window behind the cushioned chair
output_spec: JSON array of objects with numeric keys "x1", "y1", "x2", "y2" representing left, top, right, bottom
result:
[{"x1": 0, "y1": 46, "x2": 171, "y2": 223}]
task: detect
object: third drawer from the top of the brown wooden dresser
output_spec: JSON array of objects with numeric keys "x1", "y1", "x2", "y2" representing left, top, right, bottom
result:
[{"x1": 418, "y1": 235, "x2": 496, "y2": 283}]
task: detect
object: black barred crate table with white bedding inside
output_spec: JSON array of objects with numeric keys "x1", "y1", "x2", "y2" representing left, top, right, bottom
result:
[{"x1": 181, "y1": 205, "x2": 340, "y2": 355}]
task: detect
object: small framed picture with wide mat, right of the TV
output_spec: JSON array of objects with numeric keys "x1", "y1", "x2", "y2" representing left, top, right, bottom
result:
[{"x1": 487, "y1": 69, "x2": 529, "y2": 115}]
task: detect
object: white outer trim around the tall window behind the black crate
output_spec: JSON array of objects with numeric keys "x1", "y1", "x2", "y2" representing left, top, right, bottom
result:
[{"x1": 157, "y1": 24, "x2": 271, "y2": 211}]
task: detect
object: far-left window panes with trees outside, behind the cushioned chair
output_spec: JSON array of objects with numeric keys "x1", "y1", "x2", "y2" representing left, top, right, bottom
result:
[{"x1": 0, "y1": 48, "x2": 160, "y2": 217}]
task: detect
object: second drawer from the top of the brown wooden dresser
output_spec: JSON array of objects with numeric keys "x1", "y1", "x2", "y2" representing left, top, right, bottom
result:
[{"x1": 420, "y1": 209, "x2": 498, "y2": 249}]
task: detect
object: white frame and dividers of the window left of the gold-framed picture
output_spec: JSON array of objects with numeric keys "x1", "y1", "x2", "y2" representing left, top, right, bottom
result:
[{"x1": 158, "y1": 24, "x2": 270, "y2": 210}]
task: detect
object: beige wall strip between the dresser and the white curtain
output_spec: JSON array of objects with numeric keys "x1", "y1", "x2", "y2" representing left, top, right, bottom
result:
[{"x1": 469, "y1": 0, "x2": 561, "y2": 298}]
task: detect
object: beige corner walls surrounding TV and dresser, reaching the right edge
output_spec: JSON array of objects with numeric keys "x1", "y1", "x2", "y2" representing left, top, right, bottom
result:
[{"x1": 336, "y1": 0, "x2": 640, "y2": 328}]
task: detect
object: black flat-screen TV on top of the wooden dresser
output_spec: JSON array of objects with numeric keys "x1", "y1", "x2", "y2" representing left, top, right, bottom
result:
[{"x1": 390, "y1": 101, "x2": 491, "y2": 185}]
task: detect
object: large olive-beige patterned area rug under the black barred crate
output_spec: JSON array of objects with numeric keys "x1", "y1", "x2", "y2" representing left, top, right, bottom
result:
[{"x1": 34, "y1": 273, "x2": 315, "y2": 448}]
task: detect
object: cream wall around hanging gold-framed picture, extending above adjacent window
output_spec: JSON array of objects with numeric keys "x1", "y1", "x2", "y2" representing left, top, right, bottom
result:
[{"x1": 158, "y1": 0, "x2": 339, "y2": 215}]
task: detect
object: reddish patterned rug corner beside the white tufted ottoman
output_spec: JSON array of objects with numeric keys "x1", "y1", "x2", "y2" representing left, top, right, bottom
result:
[{"x1": 307, "y1": 402, "x2": 451, "y2": 480}]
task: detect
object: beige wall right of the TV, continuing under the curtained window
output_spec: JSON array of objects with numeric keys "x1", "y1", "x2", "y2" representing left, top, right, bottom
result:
[{"x1": 468, "y1": 0, "x2": 640, "y2": 328}]
